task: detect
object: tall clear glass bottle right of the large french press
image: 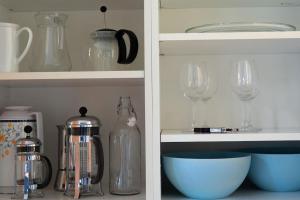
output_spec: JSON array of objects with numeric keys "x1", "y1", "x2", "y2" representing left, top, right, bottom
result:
[{"x1": 109, "y1": 97, "x2": 141, "y2": 195}]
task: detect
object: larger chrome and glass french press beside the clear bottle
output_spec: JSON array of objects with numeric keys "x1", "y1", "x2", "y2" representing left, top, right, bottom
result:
[{"x1": 65, "y1": 107, "x2": 104, "y2": 199}]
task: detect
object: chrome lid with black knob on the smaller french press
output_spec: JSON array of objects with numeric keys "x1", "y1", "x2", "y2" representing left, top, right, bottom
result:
[{"x1": 16, "y1": 126, "x2": 42, "y2": 153}]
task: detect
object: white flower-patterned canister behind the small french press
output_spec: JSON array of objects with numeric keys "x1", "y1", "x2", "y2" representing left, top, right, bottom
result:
[{"x1": 0, "y1": 106, "x2": 44, "y2": 193}]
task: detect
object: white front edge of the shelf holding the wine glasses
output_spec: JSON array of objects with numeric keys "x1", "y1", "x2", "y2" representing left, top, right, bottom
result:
[{"x1": 161, "y1": 130, "x2": 300, "y2": 142}]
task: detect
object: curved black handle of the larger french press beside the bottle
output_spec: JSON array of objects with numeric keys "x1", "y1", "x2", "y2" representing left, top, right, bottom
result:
[{"x1": 91, "y1": 137, "x2": 104, "y2": 184}]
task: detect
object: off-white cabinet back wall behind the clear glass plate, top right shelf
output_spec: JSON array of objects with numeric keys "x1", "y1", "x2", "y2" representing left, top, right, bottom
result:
[{"x1": 160, "y1": 7, "x2": 300, "y2": 33}]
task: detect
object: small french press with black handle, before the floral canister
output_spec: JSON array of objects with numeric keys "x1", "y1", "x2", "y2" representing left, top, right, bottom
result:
[{"x1": 13, "y1": 126, "x2": 52, "y2": 199}]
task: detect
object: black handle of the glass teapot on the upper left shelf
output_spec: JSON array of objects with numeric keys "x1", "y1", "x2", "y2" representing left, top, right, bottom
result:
[{"x1": 116, "y1": 29, "x2": 139, "y2": 64}]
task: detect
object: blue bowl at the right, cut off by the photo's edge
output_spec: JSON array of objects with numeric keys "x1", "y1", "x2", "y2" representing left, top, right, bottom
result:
[{"x1": 249, "y1": 149, "x2": 300, "y2": 192}]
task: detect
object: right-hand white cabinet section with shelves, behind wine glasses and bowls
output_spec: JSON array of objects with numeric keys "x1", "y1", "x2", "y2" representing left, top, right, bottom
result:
[{"x1": 152, "y1": 0, "x2": 300, "y2": 200}]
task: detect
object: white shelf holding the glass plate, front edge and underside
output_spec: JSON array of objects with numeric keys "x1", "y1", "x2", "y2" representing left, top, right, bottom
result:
[{"x1": 160, "y1": 31, "x2": 300, "y2": 55}]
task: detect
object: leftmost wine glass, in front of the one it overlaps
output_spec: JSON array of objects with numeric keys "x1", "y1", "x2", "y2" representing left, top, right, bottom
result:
[{"x1": 180, "y1": 63, "x2": 207, "y2": 128}]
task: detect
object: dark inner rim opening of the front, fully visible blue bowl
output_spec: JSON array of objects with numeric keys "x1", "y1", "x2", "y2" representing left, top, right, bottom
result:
[{"x1": 162, "y1": 151, "x2": 251, "y2": 160}]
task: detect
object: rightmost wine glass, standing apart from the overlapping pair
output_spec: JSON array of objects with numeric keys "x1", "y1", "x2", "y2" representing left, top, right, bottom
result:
[{"x1": 231, "y1": 59, "x2": 260, "y2": 132}]
